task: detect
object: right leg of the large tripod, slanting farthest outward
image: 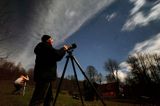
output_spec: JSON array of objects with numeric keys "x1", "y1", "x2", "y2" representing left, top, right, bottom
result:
[{"x1": 72, "y1": 56, "x2": 106, "y2": 106}]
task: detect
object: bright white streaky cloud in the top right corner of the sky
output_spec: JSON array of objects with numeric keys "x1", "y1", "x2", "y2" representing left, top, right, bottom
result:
[{"x1": 122, "y1": 0, "x2": 160, "y2": 31}]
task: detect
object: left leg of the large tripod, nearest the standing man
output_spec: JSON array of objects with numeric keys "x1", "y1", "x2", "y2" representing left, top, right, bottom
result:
[{"x1": 53, "y1": 56, "x2": 69, "y2": 106}]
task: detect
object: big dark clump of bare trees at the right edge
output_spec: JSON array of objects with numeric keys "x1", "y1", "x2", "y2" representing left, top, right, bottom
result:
[{"x1": 124, "y1": 53, "x2": 160, "y2": 99}]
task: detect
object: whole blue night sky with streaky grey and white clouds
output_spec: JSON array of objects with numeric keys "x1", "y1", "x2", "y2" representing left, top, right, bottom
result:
[{"x1": 0, "y1": 0, "x2": 160, "y2": 79}]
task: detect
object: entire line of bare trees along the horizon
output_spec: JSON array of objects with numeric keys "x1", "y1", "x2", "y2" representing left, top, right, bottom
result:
[{"x1": 0, "y1": 53, "x2": 160, "y2": 99}]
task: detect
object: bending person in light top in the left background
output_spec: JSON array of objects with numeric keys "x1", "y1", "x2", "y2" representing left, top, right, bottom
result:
[{"x1": 13, "y1": 75, "x2": 29, "y2": 95}]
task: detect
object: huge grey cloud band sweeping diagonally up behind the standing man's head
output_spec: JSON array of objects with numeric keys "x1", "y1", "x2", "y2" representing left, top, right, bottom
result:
[{"x1": 1, "y1": 0, "x2": 115, "y2": 68}]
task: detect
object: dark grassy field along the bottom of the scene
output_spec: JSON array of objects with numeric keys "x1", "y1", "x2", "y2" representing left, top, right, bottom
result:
[{"x1": 0, "y1": 80, "x2": 153, "y2": 106}]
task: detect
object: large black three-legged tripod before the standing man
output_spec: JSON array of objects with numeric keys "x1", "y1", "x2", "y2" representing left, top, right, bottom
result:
[{"x1": 53, "y1": 50, "x2": 106, "y2": 106}]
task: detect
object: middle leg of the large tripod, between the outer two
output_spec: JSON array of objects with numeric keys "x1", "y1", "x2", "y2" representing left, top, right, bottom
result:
[{"x1": 71, "y1": 57, "x2": 84, "y2": 106}]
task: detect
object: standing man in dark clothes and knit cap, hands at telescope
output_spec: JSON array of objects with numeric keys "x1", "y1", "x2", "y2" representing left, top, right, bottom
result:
[{"x1": 29, "y1": 35, "x2": 69, "y2": 106}]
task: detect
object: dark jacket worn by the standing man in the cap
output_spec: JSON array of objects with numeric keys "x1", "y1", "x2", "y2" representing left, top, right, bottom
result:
[{"x1": 34, "y1": 42, "x2": 65, "y2": 82}]
